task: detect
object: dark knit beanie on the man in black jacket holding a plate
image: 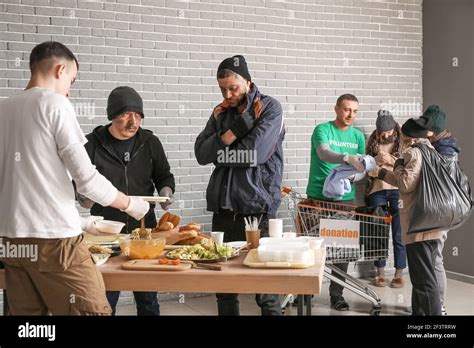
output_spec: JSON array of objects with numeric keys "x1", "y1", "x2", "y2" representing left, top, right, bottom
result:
[{"x1": 107, "y1": 86, "x2": 145, "y2": 120}]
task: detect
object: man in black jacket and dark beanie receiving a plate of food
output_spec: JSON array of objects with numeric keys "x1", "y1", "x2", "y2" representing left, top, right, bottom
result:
[{"x1": 78, "y1": 86, "x2": 175, "y2": 315}]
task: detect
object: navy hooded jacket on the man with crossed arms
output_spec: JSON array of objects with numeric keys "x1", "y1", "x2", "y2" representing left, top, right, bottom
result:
[{"x1": 194, "y1": 85, "x2": 285, "y2": 216}]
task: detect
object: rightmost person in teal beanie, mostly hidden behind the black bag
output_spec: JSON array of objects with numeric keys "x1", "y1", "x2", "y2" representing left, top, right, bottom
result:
[{"x1": 420, "y1": 105, "x2": 461, "y2": 315}]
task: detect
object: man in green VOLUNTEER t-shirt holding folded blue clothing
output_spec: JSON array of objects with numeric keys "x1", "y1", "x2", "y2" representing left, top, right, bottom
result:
[{"x1": 306, "y1": 94, "x2": 365, "y2": 311}]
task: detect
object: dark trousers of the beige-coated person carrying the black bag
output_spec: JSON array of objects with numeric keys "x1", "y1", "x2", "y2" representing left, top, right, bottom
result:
[{"x1": 406, "y1": 240, "x2": 441, "y2": 315}]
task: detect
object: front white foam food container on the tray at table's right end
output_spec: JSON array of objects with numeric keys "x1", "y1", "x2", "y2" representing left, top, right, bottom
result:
[{"x1": 258, "y1": 243, "x2": 311, "y2": 263}]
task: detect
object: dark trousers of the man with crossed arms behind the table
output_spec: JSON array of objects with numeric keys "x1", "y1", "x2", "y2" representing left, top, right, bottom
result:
[{"x1": 212, "y1": 209, "x2": 282, "y2": 315}]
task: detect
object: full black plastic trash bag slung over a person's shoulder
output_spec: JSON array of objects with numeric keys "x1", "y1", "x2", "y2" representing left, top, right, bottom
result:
[{"x1": 408, "y1": 143, "x2": 473, "y2": 234}]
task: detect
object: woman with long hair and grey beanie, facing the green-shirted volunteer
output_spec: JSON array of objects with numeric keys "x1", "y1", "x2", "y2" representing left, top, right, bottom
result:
[{"x1": 366, "y1": 110, "x2": 407, "y2": 288}]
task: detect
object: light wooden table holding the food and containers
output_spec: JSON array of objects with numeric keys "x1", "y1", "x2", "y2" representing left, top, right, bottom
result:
[{"x1": 0, "y1": 249, "x2": 325, "y2": 314}]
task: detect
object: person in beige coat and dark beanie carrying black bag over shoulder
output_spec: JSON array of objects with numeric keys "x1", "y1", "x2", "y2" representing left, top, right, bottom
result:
[{"x1": 369, "y1": 117, "x2": 444, "y2": 315}]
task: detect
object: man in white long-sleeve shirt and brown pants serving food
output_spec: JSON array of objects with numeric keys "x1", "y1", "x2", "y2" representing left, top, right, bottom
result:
[{"x1": 0, "y1": 42, "x2": 149, "y2": 315}]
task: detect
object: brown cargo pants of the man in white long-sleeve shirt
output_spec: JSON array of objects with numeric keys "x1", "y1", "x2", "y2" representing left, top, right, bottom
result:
[{"x1": 1, "y1": 235, "x2": 111, "y2": 315}]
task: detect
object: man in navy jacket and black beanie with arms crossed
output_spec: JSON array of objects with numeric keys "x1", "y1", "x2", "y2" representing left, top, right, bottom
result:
[{"x1": 194, "y1": 55, "x2": 285, "y2": 315}]
